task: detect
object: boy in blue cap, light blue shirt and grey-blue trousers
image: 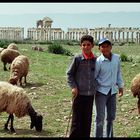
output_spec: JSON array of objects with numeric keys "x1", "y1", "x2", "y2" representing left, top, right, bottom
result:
[{"x1": 95, "y1": 38, "x2": 124, "y2": 137}]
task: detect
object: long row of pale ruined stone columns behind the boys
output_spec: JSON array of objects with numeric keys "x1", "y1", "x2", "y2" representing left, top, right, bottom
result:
[{"x1": 0, "y1": 27, "x2": 140, "y2": 43}]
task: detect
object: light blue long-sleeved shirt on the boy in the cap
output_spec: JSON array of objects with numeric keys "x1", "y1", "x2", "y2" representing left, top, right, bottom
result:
[{"x1": 95, "y1": 54, "x2": 124, "y2": 95}]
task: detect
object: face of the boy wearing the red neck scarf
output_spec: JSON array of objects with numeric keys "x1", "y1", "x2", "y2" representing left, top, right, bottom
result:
[{"x1": 80, "y1": 40, "x2": 94, "y2": 55}]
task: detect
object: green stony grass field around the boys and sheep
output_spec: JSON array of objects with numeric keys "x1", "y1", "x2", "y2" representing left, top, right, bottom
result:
[{"x1": 0, "y1": 44, "x2": 140, "y2": 138}]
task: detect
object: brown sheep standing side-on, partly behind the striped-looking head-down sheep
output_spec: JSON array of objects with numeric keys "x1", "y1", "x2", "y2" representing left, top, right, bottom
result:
[{"x1": 1, "y1": 49, "x2": 20, "y2": 71}]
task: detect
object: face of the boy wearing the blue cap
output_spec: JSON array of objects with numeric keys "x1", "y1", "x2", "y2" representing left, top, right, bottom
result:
[{"x1": 99, "y1": 42, "x2": 112, "y2": 57}]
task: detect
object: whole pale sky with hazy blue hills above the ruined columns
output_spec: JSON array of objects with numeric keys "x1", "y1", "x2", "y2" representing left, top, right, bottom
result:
[{"x1": 0, "y1": 2, "x2": 140, "y2": 36}]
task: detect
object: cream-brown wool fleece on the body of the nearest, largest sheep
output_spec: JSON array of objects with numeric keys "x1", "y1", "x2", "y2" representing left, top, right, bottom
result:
[{"x1": 0, "y1": 81, "x2": 31, "y2": 118}]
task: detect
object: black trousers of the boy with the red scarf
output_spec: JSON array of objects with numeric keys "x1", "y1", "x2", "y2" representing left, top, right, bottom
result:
[{"x1": 69, "y1": 95, "x2": 94, "y2": 138}]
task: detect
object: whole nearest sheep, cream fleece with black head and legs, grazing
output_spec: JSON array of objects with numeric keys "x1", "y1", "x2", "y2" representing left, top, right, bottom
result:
[{"x1": 0, "y1": 81, "x2": 43, "y2": 132}]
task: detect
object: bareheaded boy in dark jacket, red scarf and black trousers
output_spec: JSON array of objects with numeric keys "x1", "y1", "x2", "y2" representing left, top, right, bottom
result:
[{"x1": 67, "y1": 35, "x2": 96, "y2": 138}]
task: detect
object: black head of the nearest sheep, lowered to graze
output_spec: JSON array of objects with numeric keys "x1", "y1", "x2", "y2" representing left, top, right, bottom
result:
[{"x1": 30, "y1": 113, "x2": 43, "y2": 132}]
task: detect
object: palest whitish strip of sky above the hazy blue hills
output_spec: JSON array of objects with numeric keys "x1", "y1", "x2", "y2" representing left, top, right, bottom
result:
[{"x1": 0, "y1": 2, "x2": 140, "y2": 15}]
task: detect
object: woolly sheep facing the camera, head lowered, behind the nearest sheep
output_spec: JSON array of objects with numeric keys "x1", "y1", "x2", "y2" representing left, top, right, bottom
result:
[{"x1": 9, "y1": 55, "x2": 29, "y2": 86}]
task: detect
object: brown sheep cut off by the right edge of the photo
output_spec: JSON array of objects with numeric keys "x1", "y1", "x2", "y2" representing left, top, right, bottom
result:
[{"x1": 131, "y1": 73, "x2": 140, "y2": 114}]
